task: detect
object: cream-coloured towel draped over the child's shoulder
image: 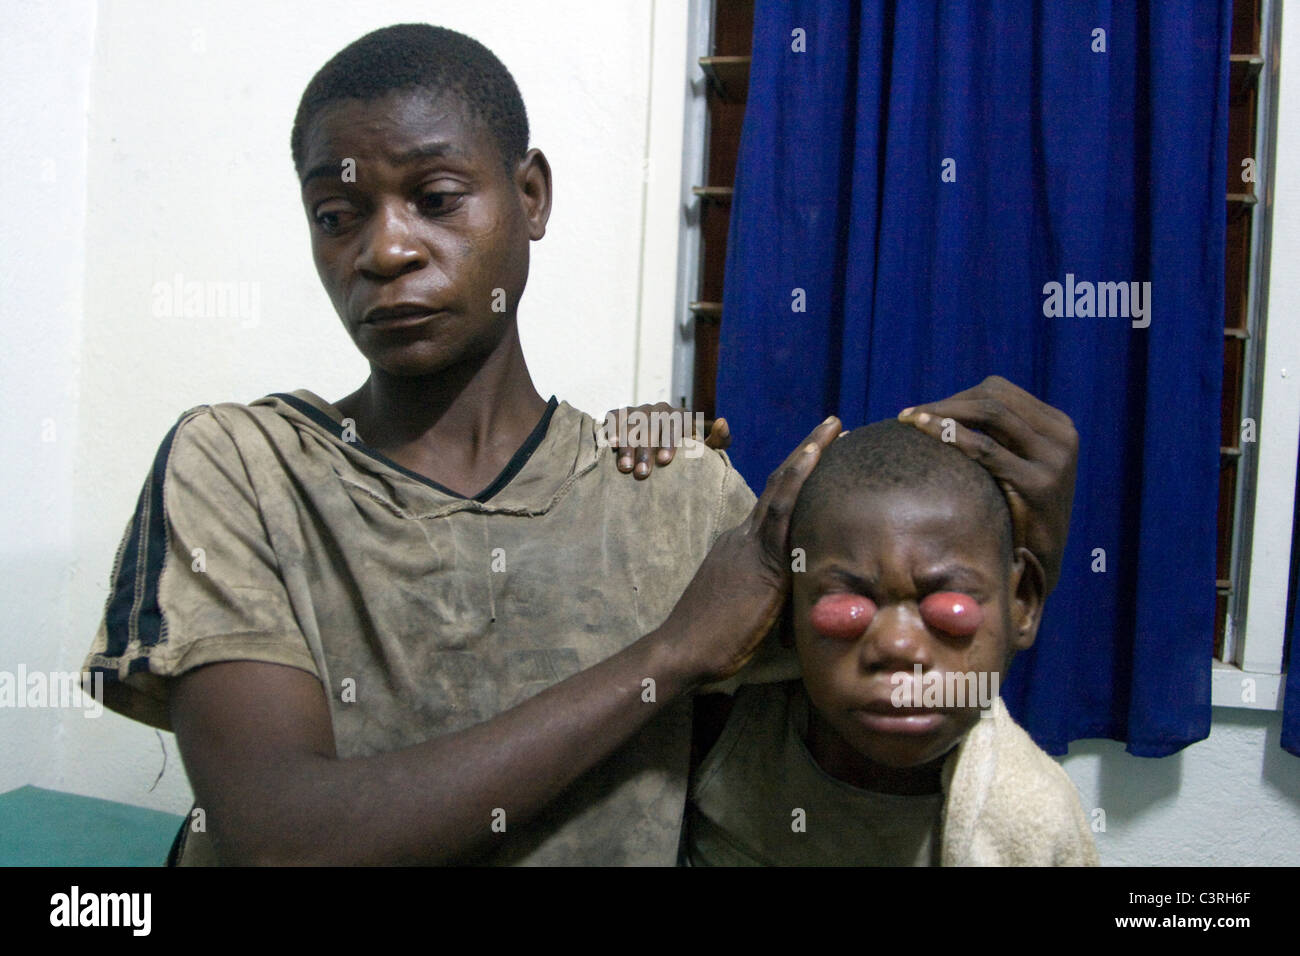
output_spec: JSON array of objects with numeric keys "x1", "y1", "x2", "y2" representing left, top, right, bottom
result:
[{"x1": 940, "y1": 697, "x2": 1101, "y2": 866}]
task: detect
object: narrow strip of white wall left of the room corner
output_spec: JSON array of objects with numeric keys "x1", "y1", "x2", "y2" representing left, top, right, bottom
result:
[{"x1": 0, "y1": 0, "x2": 96, "y2": 791}]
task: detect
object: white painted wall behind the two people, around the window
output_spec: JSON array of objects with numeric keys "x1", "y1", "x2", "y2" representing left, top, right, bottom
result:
[{"x1": 0, "y1": 0, "x2": 1300, "y2": 865}]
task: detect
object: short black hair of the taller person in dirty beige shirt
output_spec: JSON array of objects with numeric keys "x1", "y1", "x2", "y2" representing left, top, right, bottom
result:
[{"x1": 289, "y1": 23, "x2": 528, "y2": 173}]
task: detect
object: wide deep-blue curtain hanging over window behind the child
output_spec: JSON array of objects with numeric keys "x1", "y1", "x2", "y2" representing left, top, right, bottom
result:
[{"x1": 718, "y1": 0, "x2": 1230, "y2": 757}]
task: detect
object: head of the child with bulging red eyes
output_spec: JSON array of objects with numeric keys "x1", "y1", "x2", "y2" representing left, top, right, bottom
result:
[{"x1": 790, "y1": 420, "x2": 1044, "y2": 782}]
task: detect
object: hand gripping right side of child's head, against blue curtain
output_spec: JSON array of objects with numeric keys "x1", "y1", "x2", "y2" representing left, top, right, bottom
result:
[{"x1": 898, "y1": 376, "x2": 1079, "y2": 592}]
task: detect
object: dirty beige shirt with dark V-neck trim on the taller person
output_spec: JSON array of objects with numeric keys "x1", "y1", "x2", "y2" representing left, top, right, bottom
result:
[{"x1": 86, "y1": 390, "x2": 754, "y2": 865}]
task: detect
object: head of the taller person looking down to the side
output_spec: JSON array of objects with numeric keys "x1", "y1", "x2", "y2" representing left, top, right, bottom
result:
[{"x1": 290, "y1": 23, "x2": 551, "y2": 376}]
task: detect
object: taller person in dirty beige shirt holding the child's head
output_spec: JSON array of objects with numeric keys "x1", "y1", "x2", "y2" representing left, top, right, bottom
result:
[{"x1": 86, "y1": 25, "x2": 1074, "y2": 865}]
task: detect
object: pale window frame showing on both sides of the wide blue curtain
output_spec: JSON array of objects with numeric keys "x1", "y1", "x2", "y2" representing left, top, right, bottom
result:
[{"x1": 676, "y1": 0, "x2": 1300, "y2": 710}]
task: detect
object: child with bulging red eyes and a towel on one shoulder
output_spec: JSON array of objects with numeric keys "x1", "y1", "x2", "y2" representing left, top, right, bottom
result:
[{"x1": 686, "y1": 421, "x2": 1097, "y2": 866}]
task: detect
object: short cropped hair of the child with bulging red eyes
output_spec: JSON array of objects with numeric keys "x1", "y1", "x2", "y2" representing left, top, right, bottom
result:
[{"x1": 790, "y1": 419, "x2": 1014, "y2": 563}]
